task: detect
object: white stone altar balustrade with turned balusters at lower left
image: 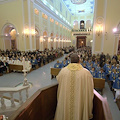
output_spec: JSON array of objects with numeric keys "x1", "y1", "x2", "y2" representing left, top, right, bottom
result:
[{"x1": 0, "y1": 85, "x2": 29, "y2": 112}]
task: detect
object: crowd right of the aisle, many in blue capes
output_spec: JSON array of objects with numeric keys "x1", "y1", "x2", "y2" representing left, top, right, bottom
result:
[{"x1": 54, "y1": 47, "x2": 120, "y2": 101}]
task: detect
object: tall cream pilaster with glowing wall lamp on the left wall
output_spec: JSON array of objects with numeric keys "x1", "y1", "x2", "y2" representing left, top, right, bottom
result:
[{"x1": 23, "y1": 0, "x2": 35, "y2": 51}]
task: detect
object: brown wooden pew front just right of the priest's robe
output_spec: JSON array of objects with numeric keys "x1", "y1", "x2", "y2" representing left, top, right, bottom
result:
[{"x1": 93, "y1": 78, "x2": 105, "y2": 94}]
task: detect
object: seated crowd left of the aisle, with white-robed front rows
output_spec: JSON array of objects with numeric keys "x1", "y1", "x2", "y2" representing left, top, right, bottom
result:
[{"x1": 0, "y1": 47, "x2": 74, "y2": 75}]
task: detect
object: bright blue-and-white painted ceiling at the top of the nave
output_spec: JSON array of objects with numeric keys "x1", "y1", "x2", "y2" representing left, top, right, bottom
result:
[{"x1": 63, "y1": 0, "x2": 94, "y2": 15}]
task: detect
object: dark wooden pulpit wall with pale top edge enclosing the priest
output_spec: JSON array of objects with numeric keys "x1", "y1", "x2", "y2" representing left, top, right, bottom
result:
[{"x1": 9, "y1": 84, "x2": 112, "y2": 120}]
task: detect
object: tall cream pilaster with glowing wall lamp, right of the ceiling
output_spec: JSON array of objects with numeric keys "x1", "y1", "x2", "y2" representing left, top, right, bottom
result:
[{"x1": 92, "y1": 0, "x2": 107, "y2": 54}]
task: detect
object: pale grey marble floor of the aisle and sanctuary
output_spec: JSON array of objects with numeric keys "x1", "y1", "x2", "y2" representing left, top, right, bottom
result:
[{"x1": 0, "y1": 56, "x2": 120, "y2": 120}]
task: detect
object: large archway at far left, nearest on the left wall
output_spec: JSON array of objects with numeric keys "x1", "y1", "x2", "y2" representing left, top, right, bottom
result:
[{"x1": 2, "y1": 23, "x2": 19, "y2": 50}]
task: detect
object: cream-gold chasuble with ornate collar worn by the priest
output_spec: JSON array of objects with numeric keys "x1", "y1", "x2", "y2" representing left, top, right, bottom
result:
[{"x1": 55, "y1": 63, "x2": 94, "y2": 120}]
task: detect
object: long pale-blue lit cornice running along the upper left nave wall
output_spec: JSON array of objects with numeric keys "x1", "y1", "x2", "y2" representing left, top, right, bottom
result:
[{"x1": 34, "y1": 0, "x2": 72, "y2": 30}]
